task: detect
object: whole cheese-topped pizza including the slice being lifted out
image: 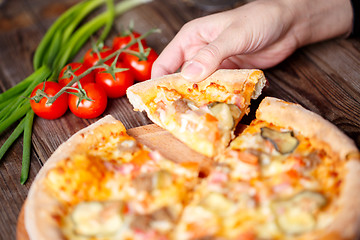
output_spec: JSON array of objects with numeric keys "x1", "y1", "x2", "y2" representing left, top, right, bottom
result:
[{"x1": 25, "y1": 70, "x2": 360, "y2": 240}]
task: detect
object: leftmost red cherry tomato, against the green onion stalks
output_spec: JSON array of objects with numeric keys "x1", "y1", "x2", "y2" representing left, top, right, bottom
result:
[{"x1": 30, "y1": 82, "x2": 68, "y2": 119}]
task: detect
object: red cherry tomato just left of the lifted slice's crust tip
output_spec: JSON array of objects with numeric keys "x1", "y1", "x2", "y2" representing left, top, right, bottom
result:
[{"x1": 95, "y1": 62, "x2": 134, "y2": 98}]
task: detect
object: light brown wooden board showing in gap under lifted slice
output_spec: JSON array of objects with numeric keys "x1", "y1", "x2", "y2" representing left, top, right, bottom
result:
[{"x1": 16, "y1": 124, "x2": 210, "y2": 240}]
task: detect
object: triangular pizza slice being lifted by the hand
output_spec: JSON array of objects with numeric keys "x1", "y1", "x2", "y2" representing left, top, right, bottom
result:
[{"x1": 127, "y1": 70, "x2": 266, "y2": 157}]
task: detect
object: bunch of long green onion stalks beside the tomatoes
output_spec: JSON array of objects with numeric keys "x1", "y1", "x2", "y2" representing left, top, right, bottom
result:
[{"x1": 0, "y1": 0, "x2": 151, "y2": 184}]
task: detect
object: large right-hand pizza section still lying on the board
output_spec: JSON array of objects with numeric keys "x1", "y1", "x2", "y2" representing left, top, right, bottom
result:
[{"x1": 175, "y1": 97, "x2": 360, "y2": 240}]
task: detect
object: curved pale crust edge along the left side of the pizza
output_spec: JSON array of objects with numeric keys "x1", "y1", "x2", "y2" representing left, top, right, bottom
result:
[{"x1": 24, "y1": 115, "x2": 126, "y2": 240}]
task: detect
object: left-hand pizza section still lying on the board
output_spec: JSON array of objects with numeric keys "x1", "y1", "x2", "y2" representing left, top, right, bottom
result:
[{"x1": 25, "y1": 116, "x2": 199, "y2": 240}]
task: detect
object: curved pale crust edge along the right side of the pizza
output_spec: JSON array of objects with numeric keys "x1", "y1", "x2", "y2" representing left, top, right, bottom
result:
[{"x1": 256, "y1": 97, "x2": 360, "y2": 239}]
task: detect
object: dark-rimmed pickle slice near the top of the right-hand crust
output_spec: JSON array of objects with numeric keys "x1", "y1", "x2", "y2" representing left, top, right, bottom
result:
[{"x1": 261, "y1": 127, "x2": 299, "y2": 154}]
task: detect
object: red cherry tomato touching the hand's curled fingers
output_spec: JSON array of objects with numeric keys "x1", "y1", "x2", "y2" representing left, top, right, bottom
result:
[{"x1": 123, "y1": 49, "x2": 158, "y2": 81}]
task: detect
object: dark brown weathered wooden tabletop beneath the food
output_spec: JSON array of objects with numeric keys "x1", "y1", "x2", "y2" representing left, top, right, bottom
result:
[{"x1": 0, "y1": 0, "x2": 360, "y2": 239}]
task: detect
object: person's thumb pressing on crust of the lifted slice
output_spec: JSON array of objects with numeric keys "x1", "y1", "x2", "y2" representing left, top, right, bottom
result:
[{"x1": 181, "y1": 31, "x2": 239, "y2": 82}]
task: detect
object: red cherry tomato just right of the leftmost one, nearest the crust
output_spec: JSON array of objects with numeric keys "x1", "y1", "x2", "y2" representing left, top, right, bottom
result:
[{"x1": 69, "y1": 83, "x2": 107, "y2": 118}]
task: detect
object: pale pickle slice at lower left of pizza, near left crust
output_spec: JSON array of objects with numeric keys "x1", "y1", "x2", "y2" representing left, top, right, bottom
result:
[{"x1": 71, "y1": 202, "x2": 123, "y2": 237}]
